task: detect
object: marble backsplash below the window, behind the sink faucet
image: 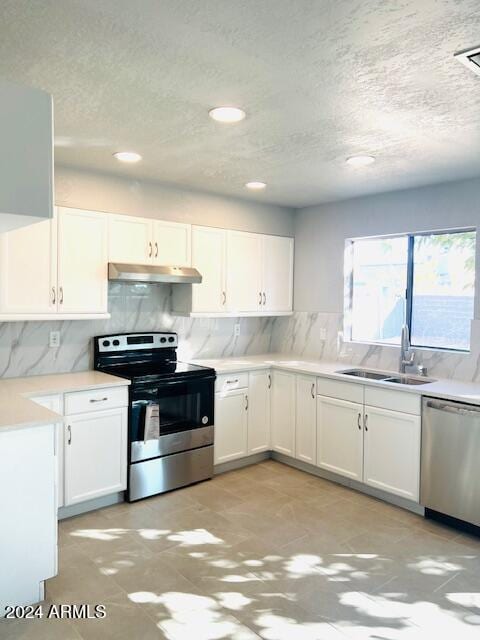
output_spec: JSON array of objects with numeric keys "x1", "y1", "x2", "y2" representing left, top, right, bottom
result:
[{"x1": 270, "y1": 311, "x2": 480, "y2": 382}]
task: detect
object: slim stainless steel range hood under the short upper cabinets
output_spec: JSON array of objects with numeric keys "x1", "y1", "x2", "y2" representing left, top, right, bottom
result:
[{"x1": 108, "y1": 262, "x2": 202, "y2": 284}]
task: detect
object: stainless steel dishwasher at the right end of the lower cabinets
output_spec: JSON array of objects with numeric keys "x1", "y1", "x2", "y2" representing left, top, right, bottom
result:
[{"x1": 420, "y1": 398, "x2": 480, "y2": 526}]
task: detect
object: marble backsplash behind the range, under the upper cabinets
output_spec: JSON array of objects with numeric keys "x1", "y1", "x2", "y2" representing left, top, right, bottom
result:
[{"x1": 0, "y1": 283, "x2": 274, "y2": 378}]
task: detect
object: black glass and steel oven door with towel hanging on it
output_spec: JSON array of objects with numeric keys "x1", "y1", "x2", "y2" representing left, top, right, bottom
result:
[{"x1": 129, "y1": 376, "x2": 215, "y2": 462}]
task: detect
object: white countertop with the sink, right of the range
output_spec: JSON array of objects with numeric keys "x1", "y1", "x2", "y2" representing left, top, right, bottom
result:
[{"x1": 194, "y1": 353, "x2": 480, "y2": 405}]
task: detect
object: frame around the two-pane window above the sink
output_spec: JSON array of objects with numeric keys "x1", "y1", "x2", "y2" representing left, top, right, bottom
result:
[{"x1": 343, "y1": 227, "x2": 478, "y2": 353}]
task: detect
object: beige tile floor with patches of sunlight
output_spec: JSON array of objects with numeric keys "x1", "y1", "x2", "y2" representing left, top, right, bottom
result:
[{"x1": 0, "y1": 460, "x2": 480, "y2": 640}]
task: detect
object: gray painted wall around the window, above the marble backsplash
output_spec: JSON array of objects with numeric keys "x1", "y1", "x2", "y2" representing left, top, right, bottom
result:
[{"x1": 294, "y1": 179, "x2": 480, "y2": 317}]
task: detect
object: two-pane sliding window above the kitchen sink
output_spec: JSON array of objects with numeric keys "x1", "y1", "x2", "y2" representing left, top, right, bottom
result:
[{"x1": 345, "y1": 230, "x2": 476, "y2": 351}]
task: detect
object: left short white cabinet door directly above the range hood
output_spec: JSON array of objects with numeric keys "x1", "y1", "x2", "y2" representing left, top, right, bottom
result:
[{"x1": 108, "y1": 215, "x2": 153, "y2": 264}]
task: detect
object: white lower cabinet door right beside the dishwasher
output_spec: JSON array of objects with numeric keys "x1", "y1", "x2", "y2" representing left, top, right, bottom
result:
[{"x1": 363, "y1": 406, "x2": 421, "y2": 502}]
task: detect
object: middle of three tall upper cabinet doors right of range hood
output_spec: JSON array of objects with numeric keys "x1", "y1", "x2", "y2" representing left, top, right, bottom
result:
[{"x1": 227, "y1": 231, "x2": 262, "y2": 312}]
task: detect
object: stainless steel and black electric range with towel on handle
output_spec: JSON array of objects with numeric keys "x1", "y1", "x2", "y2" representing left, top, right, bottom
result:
[{"x1": 94, "y1": 332, "x2": 215, "y2": 502}]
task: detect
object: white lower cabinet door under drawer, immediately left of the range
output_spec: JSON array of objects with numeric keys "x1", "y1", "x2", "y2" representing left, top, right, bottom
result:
[{"x1": 65, "y1": 408, "x2": 127, "y2": 505}]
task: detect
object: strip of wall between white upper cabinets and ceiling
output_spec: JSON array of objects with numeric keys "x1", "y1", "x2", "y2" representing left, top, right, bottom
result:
[{"x1": 55, "y1": 166, "x2": 294, "y2": 236}]
